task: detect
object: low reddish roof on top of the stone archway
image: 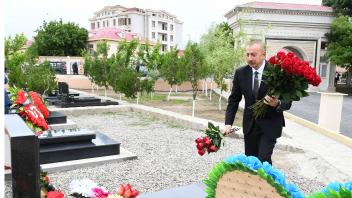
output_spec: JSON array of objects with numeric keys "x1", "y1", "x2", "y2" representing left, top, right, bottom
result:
[{"x1": 238, "y1": 1, "x2": 332, "y2": 12}]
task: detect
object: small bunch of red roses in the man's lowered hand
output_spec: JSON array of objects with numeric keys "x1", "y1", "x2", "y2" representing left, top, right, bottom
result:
[{"x1": 195, "y1": 122, "x2": 238, "y2": 156}]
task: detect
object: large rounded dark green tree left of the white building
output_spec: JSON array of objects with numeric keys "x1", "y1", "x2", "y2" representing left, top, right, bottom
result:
[{"x1": 34, "y1": 19, "x2": 88, "y2": 56}]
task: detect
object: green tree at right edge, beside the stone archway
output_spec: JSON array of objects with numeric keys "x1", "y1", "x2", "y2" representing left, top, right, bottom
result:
[{"x1": 327, "y1": 16, "x2": 352, "y2": 85}]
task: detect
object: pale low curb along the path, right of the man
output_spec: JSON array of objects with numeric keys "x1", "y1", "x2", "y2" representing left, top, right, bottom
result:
[{"x1": 284, "y1": 112, "x2": 352, "y2": 148}]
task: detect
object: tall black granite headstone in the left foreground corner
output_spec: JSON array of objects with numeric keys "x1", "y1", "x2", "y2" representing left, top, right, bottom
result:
[{"x1": 5, "y1": 114, "x2": 40, "y2": 198}]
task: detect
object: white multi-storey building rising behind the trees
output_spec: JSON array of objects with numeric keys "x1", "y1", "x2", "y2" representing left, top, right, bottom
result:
[{"x1": 89, "y1": 5, "x2": 183, "y2": 51}]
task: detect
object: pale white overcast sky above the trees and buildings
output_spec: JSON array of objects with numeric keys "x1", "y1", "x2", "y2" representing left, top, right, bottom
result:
[{"x1": 3, "y1": 0, "x2": 321, "y2": 48}]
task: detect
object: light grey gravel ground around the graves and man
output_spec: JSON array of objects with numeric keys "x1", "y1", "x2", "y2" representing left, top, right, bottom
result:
[{"x1": 5, "y1": 112, "x2": 338, "y2": 197}]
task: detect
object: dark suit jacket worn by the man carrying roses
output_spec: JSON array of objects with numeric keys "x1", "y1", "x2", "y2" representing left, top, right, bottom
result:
[{"x1": 225, "y1": 62, "x2": 292, "y2": 138}]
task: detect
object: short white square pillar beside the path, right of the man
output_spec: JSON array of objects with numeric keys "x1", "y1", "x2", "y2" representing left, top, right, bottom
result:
[{"x1": 318, "y1": 92, "x2": 347, "y2": 132}]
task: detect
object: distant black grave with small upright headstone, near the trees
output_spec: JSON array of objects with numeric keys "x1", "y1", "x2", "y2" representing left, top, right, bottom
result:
[{"x1": 45, "y1": 82, "x2": 119, "y2": 108}]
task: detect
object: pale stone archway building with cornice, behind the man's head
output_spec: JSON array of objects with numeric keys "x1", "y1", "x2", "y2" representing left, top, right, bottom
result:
[{"x1": 225, "y1": 2, "x2": 335, "y2": 91}]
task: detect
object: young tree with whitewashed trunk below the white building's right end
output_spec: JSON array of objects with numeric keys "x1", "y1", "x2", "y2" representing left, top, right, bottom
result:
[{"x1": 160, "y1": 48, "x2": 185, "y2": 100}]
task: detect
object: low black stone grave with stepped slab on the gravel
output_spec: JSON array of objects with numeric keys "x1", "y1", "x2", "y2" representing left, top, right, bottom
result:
[{"x1": 38, "y1": 129, "x2": 120, "y2": 164}]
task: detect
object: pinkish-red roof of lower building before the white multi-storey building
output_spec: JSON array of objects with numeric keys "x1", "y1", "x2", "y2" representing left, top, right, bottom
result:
[{"x1": 89, "y1": 28, "x2": 144, "y2": 42}]
